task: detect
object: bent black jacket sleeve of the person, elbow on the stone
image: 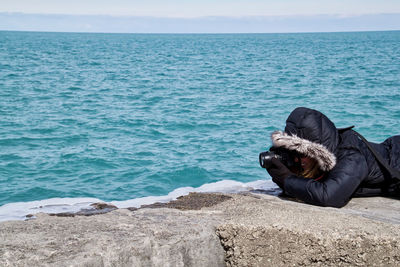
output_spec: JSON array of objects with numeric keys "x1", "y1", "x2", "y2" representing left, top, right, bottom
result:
[{"x1": 284, "y1": 148, "x2": 368, "y2": 208}]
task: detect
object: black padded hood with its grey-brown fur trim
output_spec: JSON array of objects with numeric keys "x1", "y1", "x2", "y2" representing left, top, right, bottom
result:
[{"x1": 271, "y1": 107, "x2": 339, "y2": 171}]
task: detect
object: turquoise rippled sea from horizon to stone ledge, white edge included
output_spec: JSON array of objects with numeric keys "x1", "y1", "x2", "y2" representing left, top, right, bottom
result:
[{"x1": 0, "y1": 31, "x2": 400, "y2": 221}]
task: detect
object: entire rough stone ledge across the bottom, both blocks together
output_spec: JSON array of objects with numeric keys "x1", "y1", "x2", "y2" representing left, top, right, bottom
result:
[{"x1": 0, "y1": 193, "x2": 400, "y2": 266}]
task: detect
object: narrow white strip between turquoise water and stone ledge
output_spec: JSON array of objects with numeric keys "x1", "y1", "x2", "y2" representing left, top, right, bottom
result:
[{"x1": 0, "y1": 180, "x2": 276, "y2": 222}]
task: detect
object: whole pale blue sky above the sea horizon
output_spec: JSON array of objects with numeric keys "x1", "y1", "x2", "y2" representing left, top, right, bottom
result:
[{"x1": 0, "y1": 0, "x2": 400, "y2": 32}]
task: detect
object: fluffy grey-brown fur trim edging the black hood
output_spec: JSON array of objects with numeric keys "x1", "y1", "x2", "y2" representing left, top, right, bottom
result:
[{"x1": 271, "y1": 131, "x2": 336, "y2": 171}]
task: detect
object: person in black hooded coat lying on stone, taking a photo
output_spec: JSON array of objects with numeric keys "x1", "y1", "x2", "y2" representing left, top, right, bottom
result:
[{"x1": 260, "y1": 107, "x2": 400, "y2": 207}]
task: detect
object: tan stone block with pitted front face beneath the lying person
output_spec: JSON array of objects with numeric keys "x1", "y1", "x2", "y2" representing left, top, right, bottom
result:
[{"x1": 217, "y1": 195, "x2": 400, "y2": 266}]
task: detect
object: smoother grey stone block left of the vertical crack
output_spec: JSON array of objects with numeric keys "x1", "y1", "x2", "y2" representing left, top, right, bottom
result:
[{"x1": 0, "y1": 206, "x2": 224, "y2": 266}]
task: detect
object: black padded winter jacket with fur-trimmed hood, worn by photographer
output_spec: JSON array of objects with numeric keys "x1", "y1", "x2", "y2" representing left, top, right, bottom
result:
[{"x1": 271, "y1": 107, "x2": 400, "y2": 207}]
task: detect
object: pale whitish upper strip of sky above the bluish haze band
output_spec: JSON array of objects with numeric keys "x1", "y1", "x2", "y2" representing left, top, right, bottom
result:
[{"x1": 0, "y1": 0, "x2": 400, "y2": 18}]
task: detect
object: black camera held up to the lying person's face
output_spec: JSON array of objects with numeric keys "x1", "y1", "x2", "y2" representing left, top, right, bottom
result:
[{"x1": 258, "y1": 147, "x2": 300, "y2": 169}]
